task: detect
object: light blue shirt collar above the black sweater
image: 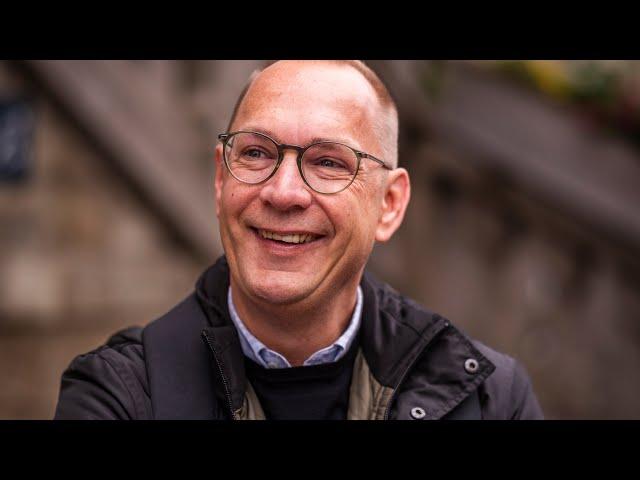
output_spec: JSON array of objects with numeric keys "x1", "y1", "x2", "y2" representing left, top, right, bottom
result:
[{"x1": 227, "y1": 286, "x2": 362, "y2": 368}]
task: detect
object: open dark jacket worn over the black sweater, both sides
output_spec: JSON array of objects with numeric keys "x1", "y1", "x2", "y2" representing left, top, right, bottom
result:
[{"x1": 55, "y1": 257, "x2": 542, "y2": 420}]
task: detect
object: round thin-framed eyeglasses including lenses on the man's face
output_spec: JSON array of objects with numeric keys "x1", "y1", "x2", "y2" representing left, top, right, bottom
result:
[{"x1": 218, "y1": 132, "x2": 392, "y2": 194}]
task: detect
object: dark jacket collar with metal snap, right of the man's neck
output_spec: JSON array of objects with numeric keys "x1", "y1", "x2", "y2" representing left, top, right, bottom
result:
[{"x1": 362, "y1": 273, "x2": 496, "y2": 419}]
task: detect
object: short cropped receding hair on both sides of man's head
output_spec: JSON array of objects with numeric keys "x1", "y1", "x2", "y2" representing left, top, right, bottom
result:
[{"x1": 222, "y1": 60, "x2": 398, "y2": 166}]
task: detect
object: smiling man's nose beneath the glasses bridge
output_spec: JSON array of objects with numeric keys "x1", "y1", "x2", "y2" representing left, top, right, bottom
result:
[{"x1": 260, "y1": 150, "x2": 311, "y2": 211}]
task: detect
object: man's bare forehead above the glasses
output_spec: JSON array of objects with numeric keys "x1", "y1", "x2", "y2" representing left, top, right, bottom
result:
[{"x1": 233, "y1": 61, "x2": 379, "y2": 148}]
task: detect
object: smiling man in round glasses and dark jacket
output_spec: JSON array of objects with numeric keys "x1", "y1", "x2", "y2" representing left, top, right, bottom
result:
[{"x1": 56, "y1": 61, "x2": 542, "y2": 420}]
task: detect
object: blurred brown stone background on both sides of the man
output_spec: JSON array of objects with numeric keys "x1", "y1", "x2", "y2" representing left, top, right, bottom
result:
[{"x1": 0, "y1": 61, "x2": 640, "y2": 419}]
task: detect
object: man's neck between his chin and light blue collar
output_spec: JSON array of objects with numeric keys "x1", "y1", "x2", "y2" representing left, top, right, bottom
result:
[{"x1": 231, "y1": 281, "x2": 358, "y2": 366}]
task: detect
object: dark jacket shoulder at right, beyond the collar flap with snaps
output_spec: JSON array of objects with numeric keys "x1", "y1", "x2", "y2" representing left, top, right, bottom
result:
[{"x1": 471, "y1": 340, "x2": 544, "y2": 420}]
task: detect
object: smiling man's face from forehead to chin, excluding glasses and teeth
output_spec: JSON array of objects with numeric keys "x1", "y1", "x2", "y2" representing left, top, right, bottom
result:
[{"x1": 216, "y1": 62, "x2": 386, "y2": 304}]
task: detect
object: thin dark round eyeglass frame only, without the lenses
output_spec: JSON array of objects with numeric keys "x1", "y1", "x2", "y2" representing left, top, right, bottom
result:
[{"x1": 218, "y1": 130, "x2": 393, "y2": 195}]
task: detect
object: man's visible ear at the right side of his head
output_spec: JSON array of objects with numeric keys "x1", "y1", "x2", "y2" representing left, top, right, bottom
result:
[{"x1": 376, "y1": 168, "x2": 411, "y2": 242}]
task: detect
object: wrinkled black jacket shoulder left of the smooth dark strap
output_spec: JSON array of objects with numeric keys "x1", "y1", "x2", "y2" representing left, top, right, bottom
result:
[{"x1": 54, "y1": 327, "x2": 151, "y2": 420}]
